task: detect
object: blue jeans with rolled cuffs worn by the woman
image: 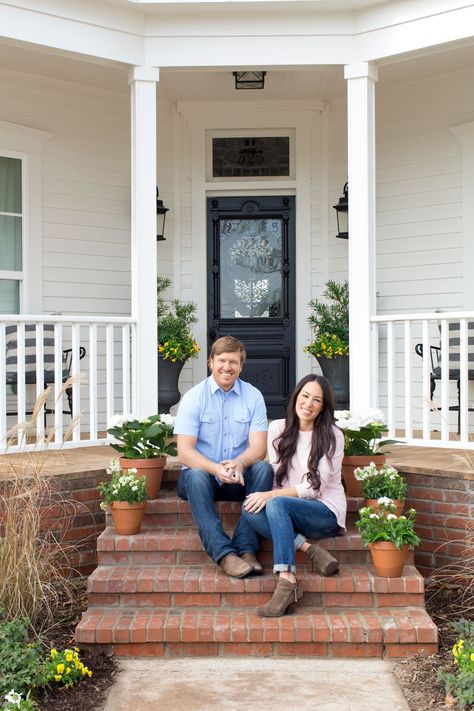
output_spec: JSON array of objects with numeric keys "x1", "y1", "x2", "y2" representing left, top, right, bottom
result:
[{"x1": 242, "y1": 496, "x2": 339, "y2": 573}]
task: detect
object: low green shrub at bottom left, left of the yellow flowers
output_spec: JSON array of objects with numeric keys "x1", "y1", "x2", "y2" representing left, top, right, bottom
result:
[{"x1": 0, "y1": 619, "x2": 44, "y2": 708}]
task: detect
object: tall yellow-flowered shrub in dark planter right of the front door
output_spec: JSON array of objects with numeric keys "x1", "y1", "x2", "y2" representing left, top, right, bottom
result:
[{"x1": 304, "y1": 280, "x2": 349, "y2": 408}]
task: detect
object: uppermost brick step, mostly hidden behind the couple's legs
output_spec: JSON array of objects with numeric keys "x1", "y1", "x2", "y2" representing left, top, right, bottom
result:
[{"x1": 120, "y1": 496, "x2": 364, "y2": 528}]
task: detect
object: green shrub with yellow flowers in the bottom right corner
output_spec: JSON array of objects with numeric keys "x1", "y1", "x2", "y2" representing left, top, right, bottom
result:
[{"x1": 438, "y1": 620, "x2": 474, "y2": 709}]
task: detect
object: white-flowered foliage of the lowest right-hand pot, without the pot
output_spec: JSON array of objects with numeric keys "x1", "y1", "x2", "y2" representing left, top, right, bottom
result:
[{"x1": 355, "y1": 496, "x2": 420, "y2": 549}]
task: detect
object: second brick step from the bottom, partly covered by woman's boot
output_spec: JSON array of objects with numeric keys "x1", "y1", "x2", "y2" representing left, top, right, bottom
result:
[{"x1": 88, "y1": 565, "x2": 424, "y2": 609}]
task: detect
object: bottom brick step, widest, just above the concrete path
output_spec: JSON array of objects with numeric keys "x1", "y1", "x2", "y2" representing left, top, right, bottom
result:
[{"x1": 76, "y1": 607, "x2": 438, "y2": 658}]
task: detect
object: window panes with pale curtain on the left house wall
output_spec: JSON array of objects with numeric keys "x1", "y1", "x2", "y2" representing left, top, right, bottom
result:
[{"x1": 0, "y1": 155, "x2": 23, "y2": 314}]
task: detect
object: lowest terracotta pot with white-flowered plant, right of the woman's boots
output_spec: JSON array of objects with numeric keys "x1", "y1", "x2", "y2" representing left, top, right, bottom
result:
[{"x1": 355, "y1": 498, "x2": 420, "y2": 578}]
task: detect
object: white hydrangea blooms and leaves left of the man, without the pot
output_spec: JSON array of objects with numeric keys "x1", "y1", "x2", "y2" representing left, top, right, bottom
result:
[{"x1": 107, "y1": 414, "x2": 178, "y2": 459}]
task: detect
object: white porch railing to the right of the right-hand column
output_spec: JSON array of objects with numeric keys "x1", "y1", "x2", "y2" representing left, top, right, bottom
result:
[{"x1": 371, "y1": 311, "x2": 474, "y2": 449}]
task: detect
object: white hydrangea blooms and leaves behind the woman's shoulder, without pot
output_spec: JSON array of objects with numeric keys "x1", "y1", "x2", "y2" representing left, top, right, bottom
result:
[{"x1": 334, "y1": 408, "x2": 397, "y2": 456}]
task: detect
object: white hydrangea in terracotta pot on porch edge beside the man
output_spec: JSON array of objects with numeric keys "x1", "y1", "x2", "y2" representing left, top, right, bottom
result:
[{"x1": 107, "y1": 414, "x2": 177, "y2": 499}]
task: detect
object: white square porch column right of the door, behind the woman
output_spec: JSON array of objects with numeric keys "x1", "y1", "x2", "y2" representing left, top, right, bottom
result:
[{"x1": 344, "y1": 62, "x2": 377, "y2": 410}]
